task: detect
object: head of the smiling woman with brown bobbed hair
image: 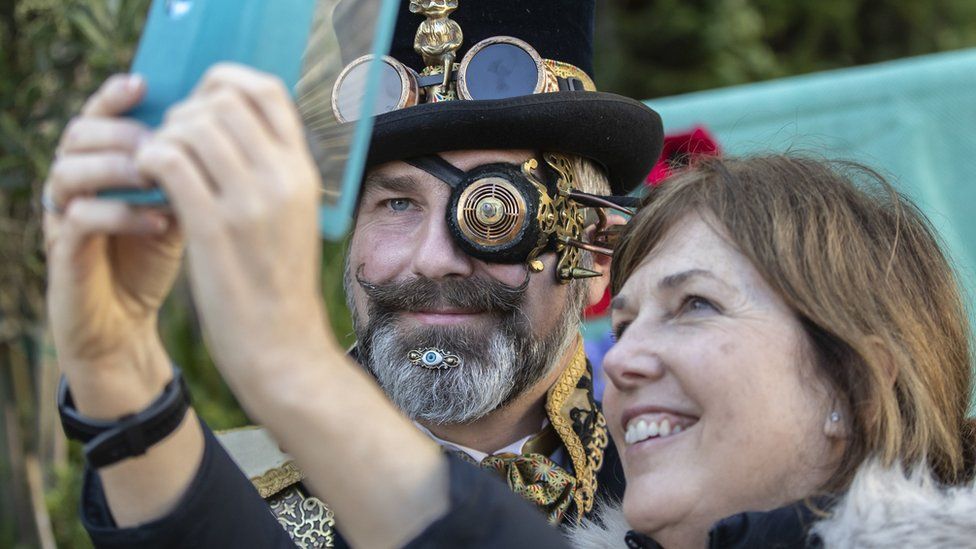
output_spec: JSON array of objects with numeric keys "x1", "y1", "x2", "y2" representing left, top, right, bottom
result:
[{"x1": 588, "y1": 156, "x2": 972, "y2": 547}]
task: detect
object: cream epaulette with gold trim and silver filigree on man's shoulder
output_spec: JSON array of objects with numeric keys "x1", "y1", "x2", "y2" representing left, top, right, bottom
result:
[{"x1": 216, "y1": 427, "x2": 335, "y2": 549}]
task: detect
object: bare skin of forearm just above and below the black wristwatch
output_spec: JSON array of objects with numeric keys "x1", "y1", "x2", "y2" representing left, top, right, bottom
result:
[{"x1": 62, "y1": 336, "x2": 203, "y2": 527}]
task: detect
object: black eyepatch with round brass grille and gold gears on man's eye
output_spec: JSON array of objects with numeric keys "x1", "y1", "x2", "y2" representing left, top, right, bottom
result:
[{"x1": 405, "y1": 153, "x2": 638, "y2": 283}]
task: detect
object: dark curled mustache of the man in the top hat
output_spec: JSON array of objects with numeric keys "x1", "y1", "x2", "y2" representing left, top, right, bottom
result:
[{"x1": 356, "y1": 265, "x2": 529, "y2": 313}]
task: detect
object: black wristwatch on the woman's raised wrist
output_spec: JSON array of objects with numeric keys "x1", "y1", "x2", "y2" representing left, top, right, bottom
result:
[{"x1": 58, "y1": 367, "x2": 190, "y2": 469}]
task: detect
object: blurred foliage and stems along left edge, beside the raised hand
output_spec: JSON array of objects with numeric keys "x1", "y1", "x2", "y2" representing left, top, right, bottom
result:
[{"x1": 0, "y1": 0, "x2": 149, "y2": 548}]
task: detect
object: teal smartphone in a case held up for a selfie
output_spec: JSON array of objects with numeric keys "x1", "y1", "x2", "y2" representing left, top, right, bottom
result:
[{"x1": 98, "y1": 0, "x2": 398, "y2": 239}]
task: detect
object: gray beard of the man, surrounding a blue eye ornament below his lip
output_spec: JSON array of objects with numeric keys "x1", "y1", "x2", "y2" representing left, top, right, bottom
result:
[{"x1": 346, "y1": 264, "x2": 585, "y2": 424}]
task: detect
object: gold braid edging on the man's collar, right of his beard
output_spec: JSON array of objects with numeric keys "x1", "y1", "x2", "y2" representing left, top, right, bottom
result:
[{"x1": 546, "y1": 341, "x2": 605, "y2": 519}]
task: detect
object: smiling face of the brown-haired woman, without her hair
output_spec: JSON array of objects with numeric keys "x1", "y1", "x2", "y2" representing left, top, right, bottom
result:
[{"x1": 604, "y1": 213, "x2": 845, "y2": 547}]
